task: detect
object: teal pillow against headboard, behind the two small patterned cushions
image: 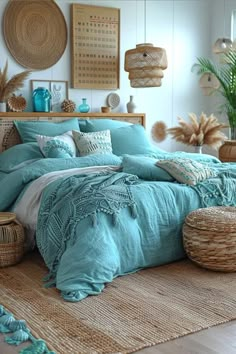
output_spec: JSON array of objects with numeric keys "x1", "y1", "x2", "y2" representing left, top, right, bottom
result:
[{"x1": 14, "y1": 118, "x2": 79, "y2": 143}]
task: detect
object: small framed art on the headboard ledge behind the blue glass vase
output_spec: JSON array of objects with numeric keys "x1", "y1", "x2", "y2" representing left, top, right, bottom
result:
[{"x1": 31, "y1": 80, "x2": 68, "y2": 112}]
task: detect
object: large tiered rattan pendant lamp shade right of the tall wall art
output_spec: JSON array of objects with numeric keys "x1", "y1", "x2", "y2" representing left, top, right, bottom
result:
[{"x1": 125, "y1": 43, "x2": 167, "y2": 87}]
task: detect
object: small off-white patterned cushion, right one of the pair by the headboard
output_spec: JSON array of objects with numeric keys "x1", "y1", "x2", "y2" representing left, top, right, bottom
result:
[{"x1": 72, "y1": 130, "x2": 112, "y2": 156}]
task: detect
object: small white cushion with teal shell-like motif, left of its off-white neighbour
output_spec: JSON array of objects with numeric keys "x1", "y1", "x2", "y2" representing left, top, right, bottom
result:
[{"x1": 36, "y1": 131, "x2": 77, "y2": 158}]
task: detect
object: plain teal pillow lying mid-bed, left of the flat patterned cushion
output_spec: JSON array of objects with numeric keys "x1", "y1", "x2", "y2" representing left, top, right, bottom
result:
[{"x1": 122, "y1": 155, "x2": 174, "y2": 182}]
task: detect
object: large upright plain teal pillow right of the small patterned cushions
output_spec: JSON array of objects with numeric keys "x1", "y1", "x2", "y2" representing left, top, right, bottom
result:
[{"x1": 111, "y1": 124, "x2": 153, "y2": 156}]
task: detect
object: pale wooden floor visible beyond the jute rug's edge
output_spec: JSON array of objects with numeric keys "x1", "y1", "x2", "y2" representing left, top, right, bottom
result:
[{"x1": 0, "y1": 321, "x2": 236, "y2": 354}]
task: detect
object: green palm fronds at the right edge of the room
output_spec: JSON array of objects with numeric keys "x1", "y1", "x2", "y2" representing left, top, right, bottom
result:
[{"x1": 192, "y1": 50, "x2": 236, "y2": 140}]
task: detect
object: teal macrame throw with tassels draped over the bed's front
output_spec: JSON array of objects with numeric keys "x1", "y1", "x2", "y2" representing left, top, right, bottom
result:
[{"x1": 36, "y1": 172, "x2": 138, "y2": 287}]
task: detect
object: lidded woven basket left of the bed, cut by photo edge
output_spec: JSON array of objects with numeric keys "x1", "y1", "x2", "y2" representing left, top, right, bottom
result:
[{"x1": 0, "y1": 221, "x2": 25, "y2": 267}]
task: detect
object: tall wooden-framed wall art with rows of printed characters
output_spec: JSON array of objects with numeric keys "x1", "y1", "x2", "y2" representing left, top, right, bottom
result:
[{"x1": 71, "y1": 4, "x2": 120, "y2": 90}]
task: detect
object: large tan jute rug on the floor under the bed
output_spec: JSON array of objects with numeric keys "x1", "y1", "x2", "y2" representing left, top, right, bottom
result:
[{"x1": 0, "y1": 250, "x2": 236, "y2": 354}]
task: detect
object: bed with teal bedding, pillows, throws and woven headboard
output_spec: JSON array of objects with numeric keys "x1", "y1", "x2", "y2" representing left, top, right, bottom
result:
[{"x1": 0, "y1": 115, "x2": 236, "y2": 302}]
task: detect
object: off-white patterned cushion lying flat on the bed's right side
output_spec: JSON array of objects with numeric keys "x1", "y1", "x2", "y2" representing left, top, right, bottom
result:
[{"x1": 156, "y1": 158, "x2": 216, "y2": 185}]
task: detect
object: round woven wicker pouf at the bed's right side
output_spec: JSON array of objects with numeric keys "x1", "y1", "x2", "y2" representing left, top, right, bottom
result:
[{"x1": 183, "y1": 206, "x2": 236, "y2": 272}]
